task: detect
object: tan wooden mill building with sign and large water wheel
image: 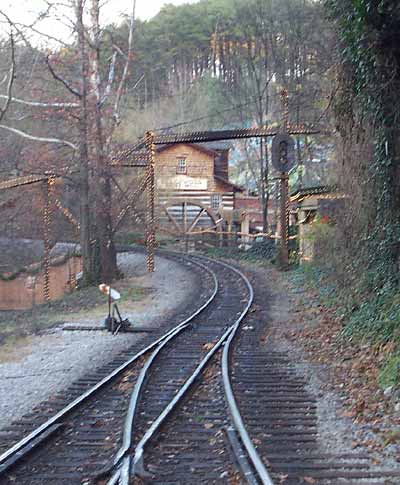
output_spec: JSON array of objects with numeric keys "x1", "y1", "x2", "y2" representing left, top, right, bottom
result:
[{"x1": 155, "y1": 142, "x2": 243, "y2": 234}]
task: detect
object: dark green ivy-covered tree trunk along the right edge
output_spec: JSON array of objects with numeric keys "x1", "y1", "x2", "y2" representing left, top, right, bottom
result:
[{"x1": 326, "y1": 0, "x2": 400, "y2": 290}]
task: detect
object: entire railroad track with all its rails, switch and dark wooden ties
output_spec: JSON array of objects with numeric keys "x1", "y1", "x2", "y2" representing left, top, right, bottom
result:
[{"x1": 0, "y1": 254, "x2": 400, "y2": 485}]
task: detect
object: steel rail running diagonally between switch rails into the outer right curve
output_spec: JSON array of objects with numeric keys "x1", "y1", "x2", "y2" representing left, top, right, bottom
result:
[{"x1": 108, "y1": 252, "x2": 260, "y2": 485}]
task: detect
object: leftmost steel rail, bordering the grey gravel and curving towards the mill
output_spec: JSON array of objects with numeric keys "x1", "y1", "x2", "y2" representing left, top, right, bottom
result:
[{"x1": 0, "y1": 255, "x2": 216, "y2": 475}]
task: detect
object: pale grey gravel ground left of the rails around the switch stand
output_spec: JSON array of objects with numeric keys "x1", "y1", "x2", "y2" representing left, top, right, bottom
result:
[{"x1": 0, "y1": 253, "x2": 196, "y2": 429}]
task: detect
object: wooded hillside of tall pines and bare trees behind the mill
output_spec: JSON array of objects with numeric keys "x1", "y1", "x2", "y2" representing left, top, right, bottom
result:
[{"x1": 2, "y1": 0, "x2": 333, "y2": 193}]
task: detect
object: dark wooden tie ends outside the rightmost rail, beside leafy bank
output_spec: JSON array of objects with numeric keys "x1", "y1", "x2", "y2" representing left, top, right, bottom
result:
[{"x1": 231, "y1": 264, "x2": 400, "y2": 485}]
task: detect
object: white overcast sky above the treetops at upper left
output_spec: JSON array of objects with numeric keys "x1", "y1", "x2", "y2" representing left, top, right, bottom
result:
[{"x1": 0, "y1": 0, "x2": 197, "y2": 44}]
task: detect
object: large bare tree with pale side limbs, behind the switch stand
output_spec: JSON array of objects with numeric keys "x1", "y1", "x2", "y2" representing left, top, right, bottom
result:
[{"x1": 0, "y1": 0, "x2": 136, "y2": 282}]
